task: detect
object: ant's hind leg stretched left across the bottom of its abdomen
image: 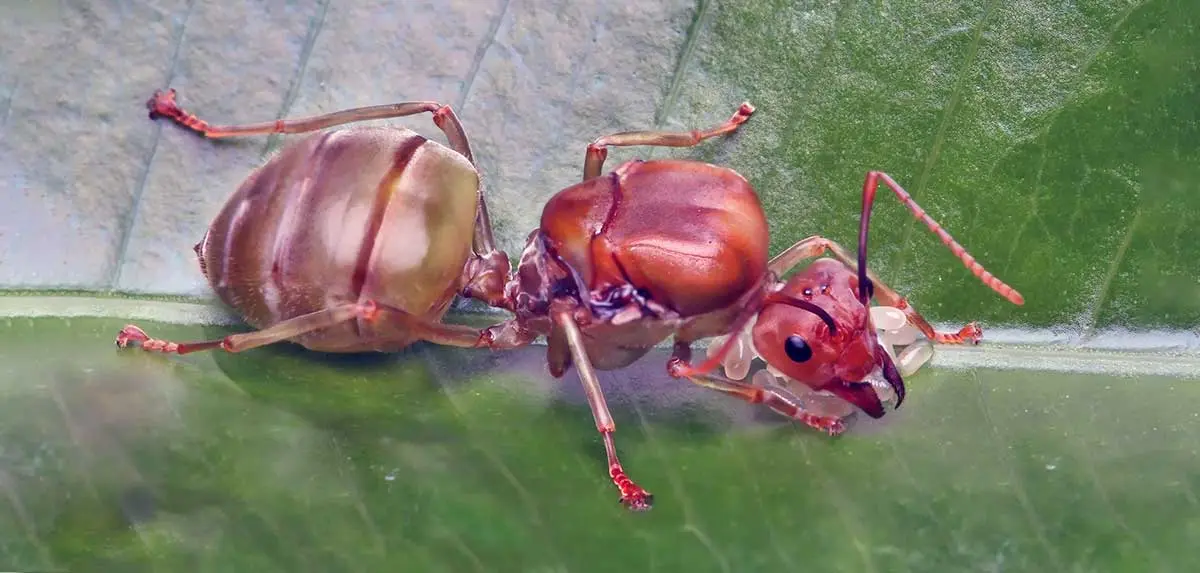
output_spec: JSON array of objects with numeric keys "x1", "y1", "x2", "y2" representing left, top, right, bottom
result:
[{"x1": 116, "y1": 301, "x2": 534, "y2": 355}]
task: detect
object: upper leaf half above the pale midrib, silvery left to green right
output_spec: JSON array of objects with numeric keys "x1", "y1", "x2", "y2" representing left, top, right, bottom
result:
[{"x1": 0, "y1": 0, "x2": 1200, "y2": 333}]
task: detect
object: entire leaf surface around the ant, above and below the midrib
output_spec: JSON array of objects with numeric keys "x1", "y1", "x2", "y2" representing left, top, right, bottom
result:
[{"x1": 0, "y1": 0, "x2": 1200, "y2": 572}]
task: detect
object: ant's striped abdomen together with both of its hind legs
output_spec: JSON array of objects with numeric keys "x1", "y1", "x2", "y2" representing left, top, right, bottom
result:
[{"x1": 118, "y1": 90, "x2": 509, "y2": 354}]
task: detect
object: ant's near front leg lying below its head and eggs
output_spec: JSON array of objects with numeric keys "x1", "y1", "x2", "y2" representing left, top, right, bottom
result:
[{"x1": 667, "y1": 340, "x2": 846, "y2": 435}]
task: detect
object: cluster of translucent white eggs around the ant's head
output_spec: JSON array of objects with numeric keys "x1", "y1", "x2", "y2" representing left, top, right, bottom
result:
[{"x1": 707, "y1": 306, "x2": 934, "y2": 402}]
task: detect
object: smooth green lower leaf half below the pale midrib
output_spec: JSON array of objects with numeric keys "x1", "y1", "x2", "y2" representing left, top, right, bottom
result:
[{"x1": 0, "y1": 319, "x2": 1200, "y2": 572}]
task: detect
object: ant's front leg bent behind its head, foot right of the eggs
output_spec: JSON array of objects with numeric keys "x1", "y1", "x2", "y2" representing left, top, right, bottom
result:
[{"x1": 768, "y1": 235, "x2": 983, "y2": 344}]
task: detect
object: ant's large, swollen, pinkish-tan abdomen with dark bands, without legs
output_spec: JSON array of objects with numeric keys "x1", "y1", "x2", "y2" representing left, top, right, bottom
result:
[{"x1": 200, "y1": 127, "x2": 478, "y2": 350}]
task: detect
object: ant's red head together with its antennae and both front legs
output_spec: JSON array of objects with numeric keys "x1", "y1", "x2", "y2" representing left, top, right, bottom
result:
[{"x1": 670, "y1": 171, "x2": 1025, "y2": 434}]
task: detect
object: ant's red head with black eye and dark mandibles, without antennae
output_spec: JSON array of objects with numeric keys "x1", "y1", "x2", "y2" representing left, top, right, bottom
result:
[{"x1": 752, "y1": 259, "x2": 904, "y2": 417}]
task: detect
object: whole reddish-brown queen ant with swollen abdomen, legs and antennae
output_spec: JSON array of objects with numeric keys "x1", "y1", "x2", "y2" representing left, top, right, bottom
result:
[{"x1": 116, "y1": 91, "x2": 1022, "y2": 509}]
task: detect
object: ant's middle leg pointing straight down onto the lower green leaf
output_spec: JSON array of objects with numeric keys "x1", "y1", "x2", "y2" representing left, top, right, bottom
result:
[{"x1": 554, "y1": 310, "x2": 654, "y2": 511}]
